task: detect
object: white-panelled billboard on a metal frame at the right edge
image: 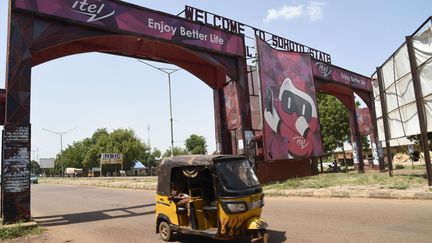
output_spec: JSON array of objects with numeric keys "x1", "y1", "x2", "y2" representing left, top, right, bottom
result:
[{"x1": 373, "y1": 23, "x2": 432, "y2": 141}]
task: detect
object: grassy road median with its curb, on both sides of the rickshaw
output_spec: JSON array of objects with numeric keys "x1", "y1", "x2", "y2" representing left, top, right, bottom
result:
[{"x1": 39, "y1": 173, "x2": 432, "y2": 200}]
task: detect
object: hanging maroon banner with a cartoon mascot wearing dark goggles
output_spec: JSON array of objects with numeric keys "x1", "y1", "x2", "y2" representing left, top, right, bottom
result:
[{"x1": 257, "y1": 39, "x2": 322, "y2": 160}]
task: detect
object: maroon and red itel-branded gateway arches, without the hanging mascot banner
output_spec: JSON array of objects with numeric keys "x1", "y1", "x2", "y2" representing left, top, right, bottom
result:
[{"x1": 0, "y1": 0, "x2": 373, "y2": 223}]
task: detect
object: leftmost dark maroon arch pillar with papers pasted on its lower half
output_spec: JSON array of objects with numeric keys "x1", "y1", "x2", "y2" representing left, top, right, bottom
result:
[{"x1": 1, "y1": 14, "x2": 33, "y2": 223}]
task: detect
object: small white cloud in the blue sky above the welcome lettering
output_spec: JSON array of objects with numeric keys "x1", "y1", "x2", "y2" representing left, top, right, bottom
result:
[{"x1": 264, "y1": 1, "x2": 326, "y2": 23}]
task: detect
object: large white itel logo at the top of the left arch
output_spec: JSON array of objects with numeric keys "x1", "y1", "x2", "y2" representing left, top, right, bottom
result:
[{"x1": 72, "y1": 0, "x2": 115, "y2": 22}]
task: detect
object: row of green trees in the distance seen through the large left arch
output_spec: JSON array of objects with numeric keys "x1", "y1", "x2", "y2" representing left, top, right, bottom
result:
[{"x1": 38, "y1": 128, "x2": 207, "y2": 175}]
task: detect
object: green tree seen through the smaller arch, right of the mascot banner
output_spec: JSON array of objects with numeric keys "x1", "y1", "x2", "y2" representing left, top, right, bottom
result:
[{"x1": 317, "y1": 93, "x2": 351, "y2": 156}]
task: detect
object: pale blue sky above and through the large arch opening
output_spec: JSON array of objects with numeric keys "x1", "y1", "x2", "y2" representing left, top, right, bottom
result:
[{"x1": 0, "y1": 0, "x2": 432, "y2": 159}]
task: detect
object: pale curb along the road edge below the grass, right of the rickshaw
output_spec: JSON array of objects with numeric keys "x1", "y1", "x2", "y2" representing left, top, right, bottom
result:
[{"x1": 264, "y1": 189, "x2": 432, "y2": 200}]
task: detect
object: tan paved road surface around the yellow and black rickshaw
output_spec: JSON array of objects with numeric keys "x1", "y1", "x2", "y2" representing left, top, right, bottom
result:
[{"x1": 17, "y1": 184, "x2": 432, "y2": 243}]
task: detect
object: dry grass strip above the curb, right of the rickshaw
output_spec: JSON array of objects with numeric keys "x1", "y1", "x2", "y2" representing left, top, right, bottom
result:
[{"x1": 264, "y1": 172, "x2": 431, "y2": 190}]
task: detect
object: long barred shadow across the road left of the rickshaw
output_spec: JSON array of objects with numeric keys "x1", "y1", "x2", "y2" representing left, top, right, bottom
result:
[{"x1": 33, "y1": 203, "x2": 156, "y2": 226}]
